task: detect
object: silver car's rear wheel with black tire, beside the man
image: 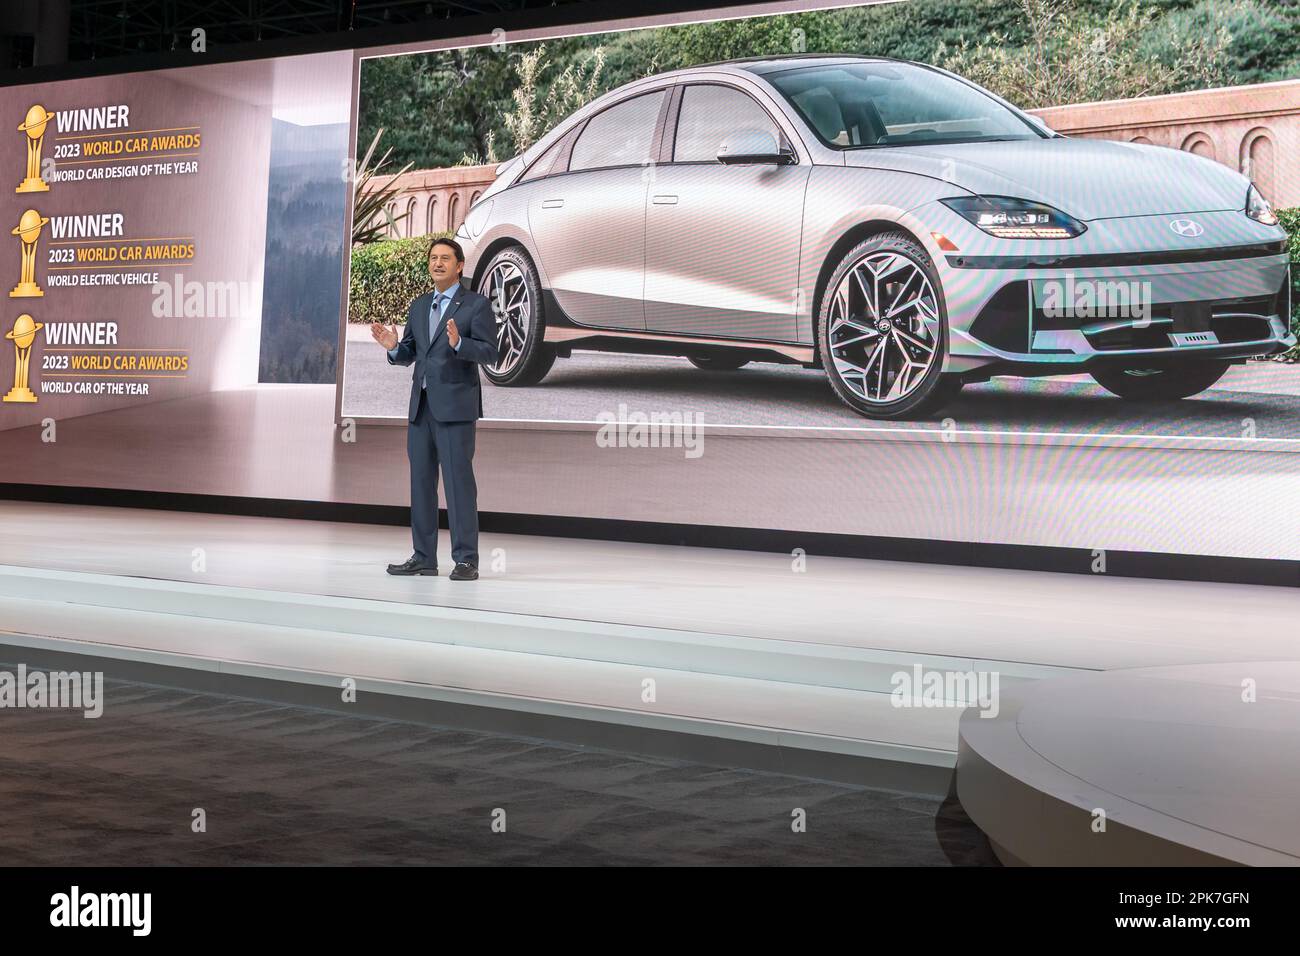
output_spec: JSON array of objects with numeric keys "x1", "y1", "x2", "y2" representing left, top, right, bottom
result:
[{"x1": 477, "y1": 246, "x2": 555, "y2": 388}]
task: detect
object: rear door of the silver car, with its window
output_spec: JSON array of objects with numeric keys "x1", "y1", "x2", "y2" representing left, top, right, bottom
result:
[{"x1": 528, "y1": 88, "x2": 667, "y2": 329}]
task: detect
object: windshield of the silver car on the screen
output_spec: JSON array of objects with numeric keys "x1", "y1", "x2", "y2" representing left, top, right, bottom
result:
[{"x1": 764, "y1": 62, "x2": 1044, "y2": 150}]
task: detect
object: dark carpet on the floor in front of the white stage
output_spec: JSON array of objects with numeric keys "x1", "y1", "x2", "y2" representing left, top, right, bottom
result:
[{"x1": 0, "y1": 680, "x2": 997, "y2": 866}]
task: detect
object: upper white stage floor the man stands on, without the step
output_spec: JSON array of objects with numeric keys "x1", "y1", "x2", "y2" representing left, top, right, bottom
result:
[{"x1": 0, "y1": 501, "x2": 1300, "y2": 670}]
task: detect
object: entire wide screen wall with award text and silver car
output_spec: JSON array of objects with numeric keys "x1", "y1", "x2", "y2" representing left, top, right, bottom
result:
[{"x1": 0, "y1": 0, "x2": 1300, "y2": 558}]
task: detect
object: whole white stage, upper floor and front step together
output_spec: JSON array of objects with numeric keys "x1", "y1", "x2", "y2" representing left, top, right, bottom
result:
[{"x1": 0, "y1": 501, "x2": 1300, "y2": 790}]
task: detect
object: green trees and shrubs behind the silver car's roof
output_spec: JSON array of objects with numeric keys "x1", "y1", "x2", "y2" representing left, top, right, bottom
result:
[{"x1": 358, "y1": 0, "x2": 1300, "y2": 169}]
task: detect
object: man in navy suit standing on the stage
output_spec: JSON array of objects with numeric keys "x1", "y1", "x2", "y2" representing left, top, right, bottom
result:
[{"x1": 371, "y1": 239, "x2": 499, "y2": 581}]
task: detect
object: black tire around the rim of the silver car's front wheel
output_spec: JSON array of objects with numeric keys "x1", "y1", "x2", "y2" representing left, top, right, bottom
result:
[{"x1": 816, "y1": 233, "x2": 962, "y2": 420}]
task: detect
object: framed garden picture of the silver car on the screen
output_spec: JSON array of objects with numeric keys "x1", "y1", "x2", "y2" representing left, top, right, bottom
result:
[{"x1": 342, "y1": 3, "x2": 1300, "y2": 440}]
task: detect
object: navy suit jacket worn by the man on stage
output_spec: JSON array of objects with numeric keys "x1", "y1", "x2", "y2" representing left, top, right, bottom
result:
[{"x1": 389, "y1": 284, "x2": 499, "y2": 421}]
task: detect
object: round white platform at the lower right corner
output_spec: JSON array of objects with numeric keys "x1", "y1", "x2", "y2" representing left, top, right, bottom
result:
[{"x1": 957, "y1": 661, "x2": 1300, "y2": 866}]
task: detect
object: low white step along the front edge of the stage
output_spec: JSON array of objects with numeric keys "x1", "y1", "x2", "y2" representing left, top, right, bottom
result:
[{"x1": 0, "y1": 566, "x2": 1078, "y2": 769}]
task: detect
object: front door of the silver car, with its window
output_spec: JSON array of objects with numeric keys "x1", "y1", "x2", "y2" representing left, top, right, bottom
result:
[{"x1": 645, "y1": 82, "x2": 810, "y2": 341}]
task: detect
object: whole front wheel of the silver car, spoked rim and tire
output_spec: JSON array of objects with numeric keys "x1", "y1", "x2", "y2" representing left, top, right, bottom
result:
[{"x1": 818, "y1": 233, "x2": 962, "y2": 419}]
